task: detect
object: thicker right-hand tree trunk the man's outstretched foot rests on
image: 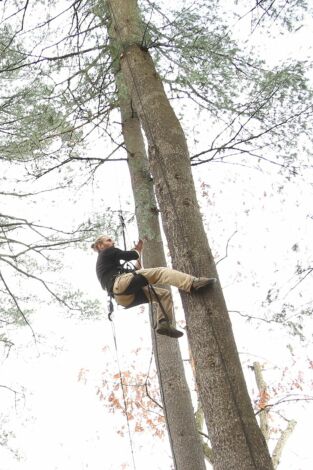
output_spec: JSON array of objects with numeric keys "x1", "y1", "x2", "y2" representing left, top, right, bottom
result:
[{"x1": 108, "y1": 0, "x2": 273, "y2": 470}]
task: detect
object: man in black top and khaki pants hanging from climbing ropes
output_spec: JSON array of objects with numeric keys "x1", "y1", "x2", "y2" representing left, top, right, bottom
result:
[{"x1": 91, "y1": 235, "x2": 216, "y2": 338}]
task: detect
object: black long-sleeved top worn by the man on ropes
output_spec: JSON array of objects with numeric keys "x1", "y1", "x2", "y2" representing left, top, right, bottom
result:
[{"x1": 96, "y1": 246, "x2": 139, "y2": 292}]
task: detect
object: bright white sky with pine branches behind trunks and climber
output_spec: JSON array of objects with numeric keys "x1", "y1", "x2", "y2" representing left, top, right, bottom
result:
[{"x1": 0, "y1": 1, "x2": 312, "y2": 470}]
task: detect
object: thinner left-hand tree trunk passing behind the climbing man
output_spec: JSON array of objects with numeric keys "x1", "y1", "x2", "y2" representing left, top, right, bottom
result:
[{"x1": 107, "y1": 12, "x2": 206, "y2": 470}]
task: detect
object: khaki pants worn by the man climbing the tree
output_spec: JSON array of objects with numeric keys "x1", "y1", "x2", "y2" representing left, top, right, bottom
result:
[{"x1": 113, "y1": 268, "x2": 194, "y2": 323}]
